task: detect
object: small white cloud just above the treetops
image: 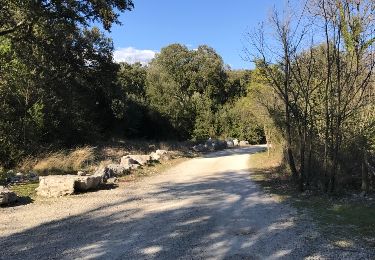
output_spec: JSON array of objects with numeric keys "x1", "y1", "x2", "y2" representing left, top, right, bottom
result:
[{"x1": 113, "y1": 47, "x2": 157, "y2": 65}]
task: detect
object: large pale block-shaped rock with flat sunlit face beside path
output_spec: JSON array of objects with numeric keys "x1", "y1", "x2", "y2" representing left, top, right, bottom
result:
[{"x1": 36, "y1": 175, "x2": 77, "y2": 197}]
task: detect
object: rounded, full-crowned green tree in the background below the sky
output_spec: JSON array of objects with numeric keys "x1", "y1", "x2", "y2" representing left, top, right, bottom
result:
[{"x1": 146, "y1": 44, "x2": 226, "y2": 138}]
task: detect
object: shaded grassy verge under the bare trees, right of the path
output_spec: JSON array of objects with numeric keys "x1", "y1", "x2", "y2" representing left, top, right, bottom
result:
[{"x1": 249, "y1": 148, "x2": 375, "y2": 247}]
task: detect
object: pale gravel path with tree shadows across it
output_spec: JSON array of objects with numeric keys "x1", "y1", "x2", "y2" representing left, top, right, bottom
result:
[{"x1": 0, "y1": 146, "x2": 369, "y2": 259}]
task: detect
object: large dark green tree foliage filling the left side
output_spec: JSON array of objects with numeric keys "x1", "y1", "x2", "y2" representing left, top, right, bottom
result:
[{"x1": 0, "y1": 0, "x2": 133, "y2": 167}]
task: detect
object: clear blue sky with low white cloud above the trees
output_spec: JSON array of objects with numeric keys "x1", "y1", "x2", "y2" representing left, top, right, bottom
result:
[{"x1": 109, "y1": 0, "x2": 284, "y2": 69}]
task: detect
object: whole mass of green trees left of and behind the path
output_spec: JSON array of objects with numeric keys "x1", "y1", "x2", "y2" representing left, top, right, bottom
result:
[{"x1": 0, "y1": 0, "x2": 262, "y2": 168}]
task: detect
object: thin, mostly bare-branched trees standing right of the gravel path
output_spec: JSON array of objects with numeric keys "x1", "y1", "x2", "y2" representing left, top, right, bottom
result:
[{"x1": 248, "y1": 0, "x2": 375, "y2": 192}]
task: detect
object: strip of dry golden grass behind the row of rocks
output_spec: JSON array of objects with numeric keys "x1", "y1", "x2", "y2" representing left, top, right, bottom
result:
[{"x1": 17, "y1": 140, "x2": 194, "y2": 175}]
